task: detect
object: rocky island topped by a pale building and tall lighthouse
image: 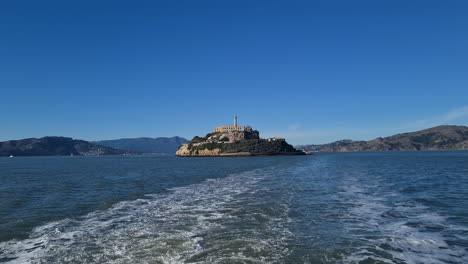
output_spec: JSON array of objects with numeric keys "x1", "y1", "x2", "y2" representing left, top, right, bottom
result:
[{"x1": 176, "y1": 116, "x2": 305, "y2": 157}]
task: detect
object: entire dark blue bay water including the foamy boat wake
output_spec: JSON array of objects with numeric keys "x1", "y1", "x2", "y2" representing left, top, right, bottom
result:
[{"x1": 0, "y1": 151, "x2": 468, "y2": 263}]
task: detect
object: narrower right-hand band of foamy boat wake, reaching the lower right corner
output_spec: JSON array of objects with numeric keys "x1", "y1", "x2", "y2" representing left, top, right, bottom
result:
[{"x1": 337, "y1": 175, "x2": 468, "y2": 264}]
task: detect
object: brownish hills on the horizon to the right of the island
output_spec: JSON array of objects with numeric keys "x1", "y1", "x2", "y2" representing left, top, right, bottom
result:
[{"x1": 296, "y1": 126, "x2": 468, "y2": 152}]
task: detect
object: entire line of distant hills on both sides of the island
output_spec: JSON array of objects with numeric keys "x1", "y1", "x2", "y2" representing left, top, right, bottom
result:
[{"x1": 0, "y1": 126, "x2": 468, "y2": 156}]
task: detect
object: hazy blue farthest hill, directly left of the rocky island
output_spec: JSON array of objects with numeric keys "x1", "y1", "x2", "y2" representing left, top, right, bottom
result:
[{"x1": 93, "y1": 137, "x2": 188, "y2": 154}]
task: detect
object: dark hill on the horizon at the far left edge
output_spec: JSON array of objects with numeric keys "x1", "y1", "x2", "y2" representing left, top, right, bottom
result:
[{"x1": 0, "y1": 137, "x2": 132, "y2": 156}]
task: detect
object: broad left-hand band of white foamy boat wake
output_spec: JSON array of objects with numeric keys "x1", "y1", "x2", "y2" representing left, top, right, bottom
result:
[{"x1": 0, "y1": 168, "x2": 291, "y2": 263}]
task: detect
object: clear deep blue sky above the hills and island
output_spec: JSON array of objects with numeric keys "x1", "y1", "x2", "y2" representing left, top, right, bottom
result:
[{"x1": 0, "y1": 0, "x2": 468, "y2": 144}]
